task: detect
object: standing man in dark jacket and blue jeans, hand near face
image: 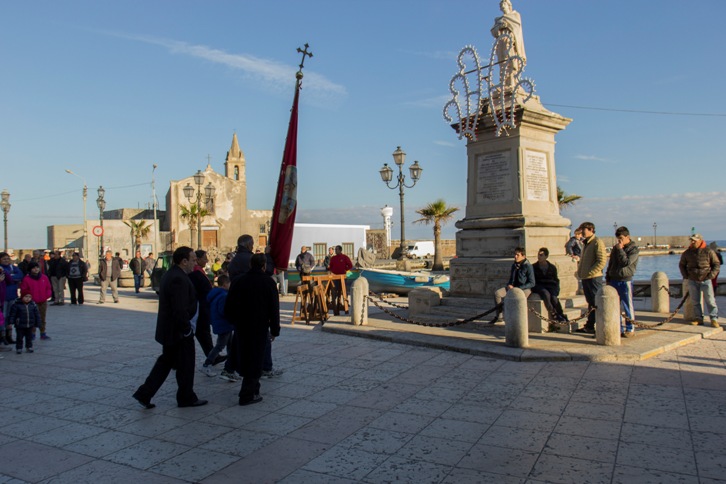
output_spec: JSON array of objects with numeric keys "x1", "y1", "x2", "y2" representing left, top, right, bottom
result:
[{"x1": 605, "y1": 227, "x2": 639, "y2": 338}]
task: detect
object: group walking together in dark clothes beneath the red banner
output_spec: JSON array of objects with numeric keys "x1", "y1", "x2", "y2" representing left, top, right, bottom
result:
[{"x1": 133, "y1": 234, "x2": 282, "y2": 409}]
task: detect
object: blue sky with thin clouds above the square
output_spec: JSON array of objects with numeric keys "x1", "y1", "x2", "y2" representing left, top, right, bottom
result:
[{"x1": 0, "y1": 0, "x2": 726, "y2": 248}]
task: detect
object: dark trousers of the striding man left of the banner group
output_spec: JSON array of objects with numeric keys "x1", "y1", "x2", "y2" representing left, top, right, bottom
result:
[{"x1": 136, "y1": 336, "x2": 197, "y2": 405}]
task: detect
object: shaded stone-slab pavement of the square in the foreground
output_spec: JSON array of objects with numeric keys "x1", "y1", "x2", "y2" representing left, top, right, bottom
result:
[{"x1": 0, "y1": 286, "x2": 726, "y2": 483}]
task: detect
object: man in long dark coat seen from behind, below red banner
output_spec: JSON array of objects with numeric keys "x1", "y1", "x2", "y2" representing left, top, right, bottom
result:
[{"x1": 224, "y1": 254, "x2": 280, "y2": 405}]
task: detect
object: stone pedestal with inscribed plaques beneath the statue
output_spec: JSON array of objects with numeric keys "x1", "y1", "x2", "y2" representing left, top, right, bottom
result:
[{"x1": 451, "y1": 96, "x2": 577, "y2": 298}]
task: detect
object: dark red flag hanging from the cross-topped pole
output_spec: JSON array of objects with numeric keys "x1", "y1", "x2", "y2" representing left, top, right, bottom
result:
[{"x1": 270, "y1": 82, "x2": 300, "y2": 269}]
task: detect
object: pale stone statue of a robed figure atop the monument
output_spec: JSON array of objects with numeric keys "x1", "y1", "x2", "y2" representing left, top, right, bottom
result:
[{"x1": 491, "y1": 0, "x2": 527, "y2": 90}]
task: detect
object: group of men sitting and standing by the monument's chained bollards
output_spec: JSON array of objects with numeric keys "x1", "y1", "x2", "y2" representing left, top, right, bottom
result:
[{"x1": 494, "y1": 222, "x2": 722, "y2": 338}]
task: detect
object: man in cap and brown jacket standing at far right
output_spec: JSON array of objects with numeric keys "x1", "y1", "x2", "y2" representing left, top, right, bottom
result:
[{"x1": 678, "y1": 234, "x2": 721, "y2": 328}]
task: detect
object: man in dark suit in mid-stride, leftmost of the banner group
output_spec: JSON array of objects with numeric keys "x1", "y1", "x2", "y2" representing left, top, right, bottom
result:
[{"x1": 133, "y1": 247, "x2": 207, "y2": 409}]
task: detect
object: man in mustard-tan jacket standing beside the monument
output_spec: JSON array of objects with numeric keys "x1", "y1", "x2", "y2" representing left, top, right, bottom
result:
[{"x1": 576, "y1": 222, "x2": 607, "y2": 334}]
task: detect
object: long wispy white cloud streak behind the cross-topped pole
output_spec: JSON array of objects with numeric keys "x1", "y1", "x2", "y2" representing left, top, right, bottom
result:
[{"x1": 109, "y1": 33, "x2": 348, "y2": 104}]
